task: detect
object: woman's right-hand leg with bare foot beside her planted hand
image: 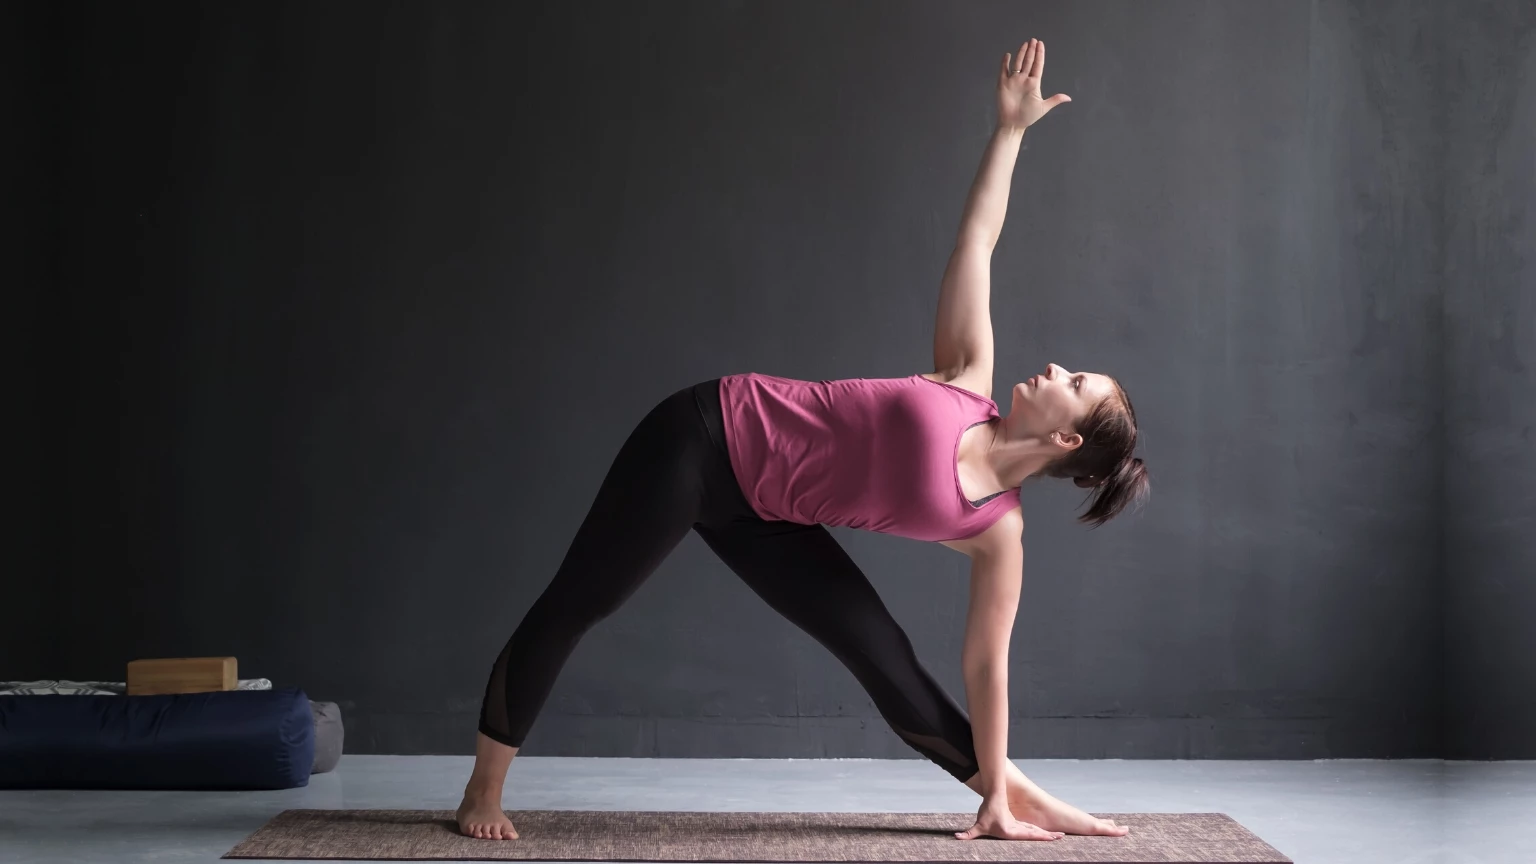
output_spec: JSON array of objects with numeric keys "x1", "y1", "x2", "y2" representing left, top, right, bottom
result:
[{"x1": 694, "y1": 520, "x2": 1127, "y2": 836}]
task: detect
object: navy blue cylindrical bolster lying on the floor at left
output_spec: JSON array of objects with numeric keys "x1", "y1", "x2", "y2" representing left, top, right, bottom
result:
[{"x1": 0, "y1": 687, "x2": 315, "y2": 789}]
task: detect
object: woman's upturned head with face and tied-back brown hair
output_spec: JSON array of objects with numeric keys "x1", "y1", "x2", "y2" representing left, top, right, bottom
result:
[{"x1": 1008, "y1": 363, "x2": 1149, "y2": 527}]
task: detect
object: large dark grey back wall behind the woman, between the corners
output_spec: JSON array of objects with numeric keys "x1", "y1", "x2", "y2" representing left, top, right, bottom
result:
[{"x1": 27, "y1": 3, "x2": 1528, "y2": 758}]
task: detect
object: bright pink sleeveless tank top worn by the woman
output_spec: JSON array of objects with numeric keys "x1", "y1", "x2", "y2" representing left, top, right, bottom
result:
[{"x1": 720, "y1": 372, "x2": 1018, "y2": 540}]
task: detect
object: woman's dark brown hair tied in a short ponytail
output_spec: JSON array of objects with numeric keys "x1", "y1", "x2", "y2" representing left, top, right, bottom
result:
[{"x1": 1041, "y1": 381, "x2": 1150, "y2": 527}]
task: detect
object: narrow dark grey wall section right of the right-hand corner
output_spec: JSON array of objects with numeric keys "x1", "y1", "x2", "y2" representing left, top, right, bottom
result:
[{"x1": 1442, "y1": 2, "x2": 1536, "y2": 759}]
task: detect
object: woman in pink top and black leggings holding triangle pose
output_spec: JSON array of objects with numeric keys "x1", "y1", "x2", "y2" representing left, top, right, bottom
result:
[{"x1": 458, "y1": 40, "x2": 1147, "y2": 839}]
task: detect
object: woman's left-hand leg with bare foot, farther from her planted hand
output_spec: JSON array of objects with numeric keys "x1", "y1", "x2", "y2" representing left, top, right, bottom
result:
[{"x1": 458, "y1": 389, "x2": 714, "y2": 839}]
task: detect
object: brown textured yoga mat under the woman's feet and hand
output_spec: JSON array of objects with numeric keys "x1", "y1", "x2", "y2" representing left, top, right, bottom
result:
[{"x1": 224, "y1": 810, "x2": 1290, "y2": 864}]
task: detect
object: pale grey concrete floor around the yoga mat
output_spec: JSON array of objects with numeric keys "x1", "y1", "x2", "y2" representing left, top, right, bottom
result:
[{"x1": 0, "y1": 755, "x2": 1536, "y2": 864}]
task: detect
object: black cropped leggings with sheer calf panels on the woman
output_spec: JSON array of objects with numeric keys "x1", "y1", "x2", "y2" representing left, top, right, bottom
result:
[{"x1": 479, "y1": 378, "x2": 978, "y2": 783}]
